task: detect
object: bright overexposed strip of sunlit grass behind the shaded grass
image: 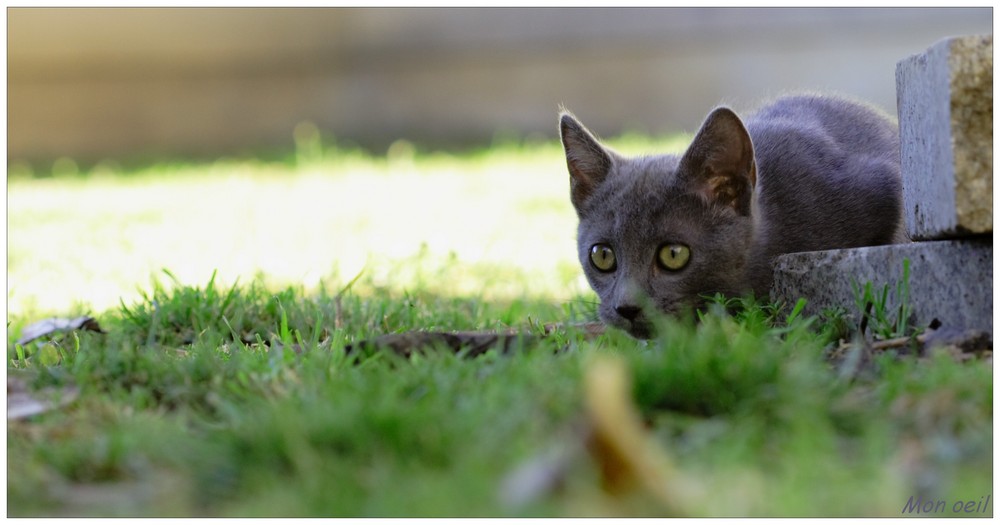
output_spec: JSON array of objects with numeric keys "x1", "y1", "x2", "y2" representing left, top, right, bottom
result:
[{"x1": 7, "y1": 133, "x2": 677, "y2": 314}]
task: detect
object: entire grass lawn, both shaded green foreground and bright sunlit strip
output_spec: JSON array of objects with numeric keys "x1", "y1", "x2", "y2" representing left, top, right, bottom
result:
[{"x1": 7, "y1": 134, "x2": 993, "y2": 517}]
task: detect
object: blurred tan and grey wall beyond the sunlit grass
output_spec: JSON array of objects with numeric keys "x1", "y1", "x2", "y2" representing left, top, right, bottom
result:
[{"x1": 7, "y1": 8, "x2": 992, "y2": 165}]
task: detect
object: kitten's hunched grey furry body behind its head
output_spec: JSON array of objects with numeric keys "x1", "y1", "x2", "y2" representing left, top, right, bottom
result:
[{"x1": 745, "y1": 95, "x2": 905, "y2": 290}]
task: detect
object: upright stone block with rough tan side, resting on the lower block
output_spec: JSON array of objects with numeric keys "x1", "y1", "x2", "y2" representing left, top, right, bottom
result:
[{"x1": 896, "y1": 35, "x2": 993, "y2": 240}]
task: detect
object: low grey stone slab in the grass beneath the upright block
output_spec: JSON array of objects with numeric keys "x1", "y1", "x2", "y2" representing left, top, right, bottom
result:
[{"x1": 771, "y1": 238, "x2": 993, "y2": 335}]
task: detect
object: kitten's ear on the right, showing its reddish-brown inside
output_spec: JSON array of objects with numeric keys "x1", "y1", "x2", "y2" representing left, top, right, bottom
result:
[{"x1": 677, "y1": 107, "x2": 757, "y2": 216}]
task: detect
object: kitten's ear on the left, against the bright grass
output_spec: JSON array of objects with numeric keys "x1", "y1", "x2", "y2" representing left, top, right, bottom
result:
[{"x1": 559, "y1": 110, "x2": 612, "y2": 214}]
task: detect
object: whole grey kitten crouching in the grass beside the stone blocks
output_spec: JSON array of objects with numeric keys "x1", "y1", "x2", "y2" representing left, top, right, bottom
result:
[{"x1": 560, "y1": 95, "x2": 907, "y2": 338}]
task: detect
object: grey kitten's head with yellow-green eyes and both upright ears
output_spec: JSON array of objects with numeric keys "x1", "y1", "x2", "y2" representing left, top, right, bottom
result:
[{"x1": 559, "y1": 108, "x2": 756, "y2": 339}]
